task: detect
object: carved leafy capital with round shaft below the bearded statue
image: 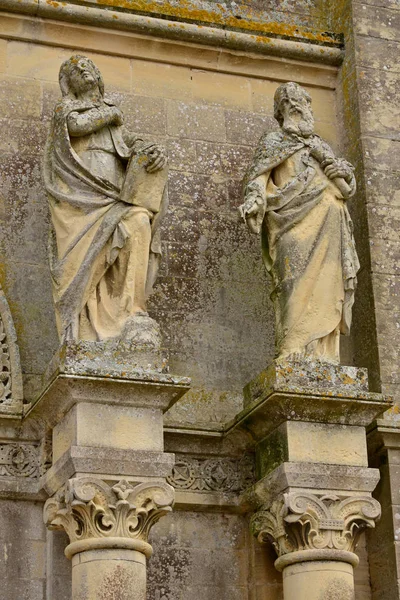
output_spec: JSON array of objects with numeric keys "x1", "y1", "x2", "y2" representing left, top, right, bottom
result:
[{"x1": 251, "y1": 491, "x2": 381, "y2": 600}]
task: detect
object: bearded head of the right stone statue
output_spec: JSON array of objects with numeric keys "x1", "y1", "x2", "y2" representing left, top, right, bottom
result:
[{"x1": 274, "y1": 81, "x2": 314, "y2": 137}]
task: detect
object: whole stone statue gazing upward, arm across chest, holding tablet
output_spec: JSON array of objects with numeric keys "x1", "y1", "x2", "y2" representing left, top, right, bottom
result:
[{"x1": 44, "y1": 55, "x2": 167, "y2": 341}]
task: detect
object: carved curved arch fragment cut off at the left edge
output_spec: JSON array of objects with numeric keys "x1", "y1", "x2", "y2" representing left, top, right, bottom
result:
[{"x1": 0, "y1": 288, "x2": 23, "y2": 416}]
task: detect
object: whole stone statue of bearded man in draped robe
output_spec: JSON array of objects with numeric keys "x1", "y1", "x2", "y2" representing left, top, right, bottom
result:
[{"x1": 240, "y1": 82, "x2": 359, "y2": 363}]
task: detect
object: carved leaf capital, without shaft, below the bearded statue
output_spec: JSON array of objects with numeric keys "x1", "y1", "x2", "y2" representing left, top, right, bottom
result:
[{"x1": 251, "y1": 492, "x2": 381, "y2": 556}]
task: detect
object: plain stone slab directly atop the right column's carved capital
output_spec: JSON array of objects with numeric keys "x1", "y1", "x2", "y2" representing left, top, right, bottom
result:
[{"x1": 242, "y1": 462, "x2": 380, "y2": 510}]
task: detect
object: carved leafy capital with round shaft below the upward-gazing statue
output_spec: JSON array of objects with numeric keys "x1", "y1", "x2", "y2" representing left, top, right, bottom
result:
[{"x1": 44, "y1": 477, "x2": 174, "y2": 600}]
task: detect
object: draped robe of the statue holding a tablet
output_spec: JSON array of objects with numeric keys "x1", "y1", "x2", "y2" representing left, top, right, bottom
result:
[{"x1": 44, "y1": 97, "x2": 167, "y2": 340}]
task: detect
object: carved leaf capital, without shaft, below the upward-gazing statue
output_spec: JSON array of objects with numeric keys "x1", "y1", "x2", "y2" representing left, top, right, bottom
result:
[{"x1": 44, "y1": 477, "x2": 174, "y2": 557}]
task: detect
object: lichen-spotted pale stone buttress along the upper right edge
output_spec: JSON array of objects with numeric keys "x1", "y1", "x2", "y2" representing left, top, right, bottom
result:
[{"x1": 353, "y1": 0, "x2": 400, "y2": 420}]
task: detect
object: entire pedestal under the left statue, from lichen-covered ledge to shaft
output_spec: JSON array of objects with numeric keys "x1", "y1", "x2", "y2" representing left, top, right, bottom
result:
[{"x1": 27, "y1": 342, "x2": 190, "y2": 600}]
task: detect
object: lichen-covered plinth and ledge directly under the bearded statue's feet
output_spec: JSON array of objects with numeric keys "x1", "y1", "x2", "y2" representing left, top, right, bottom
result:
[{"x1": 225, "y1": 361, "x2": 392, "y2": 441}]
